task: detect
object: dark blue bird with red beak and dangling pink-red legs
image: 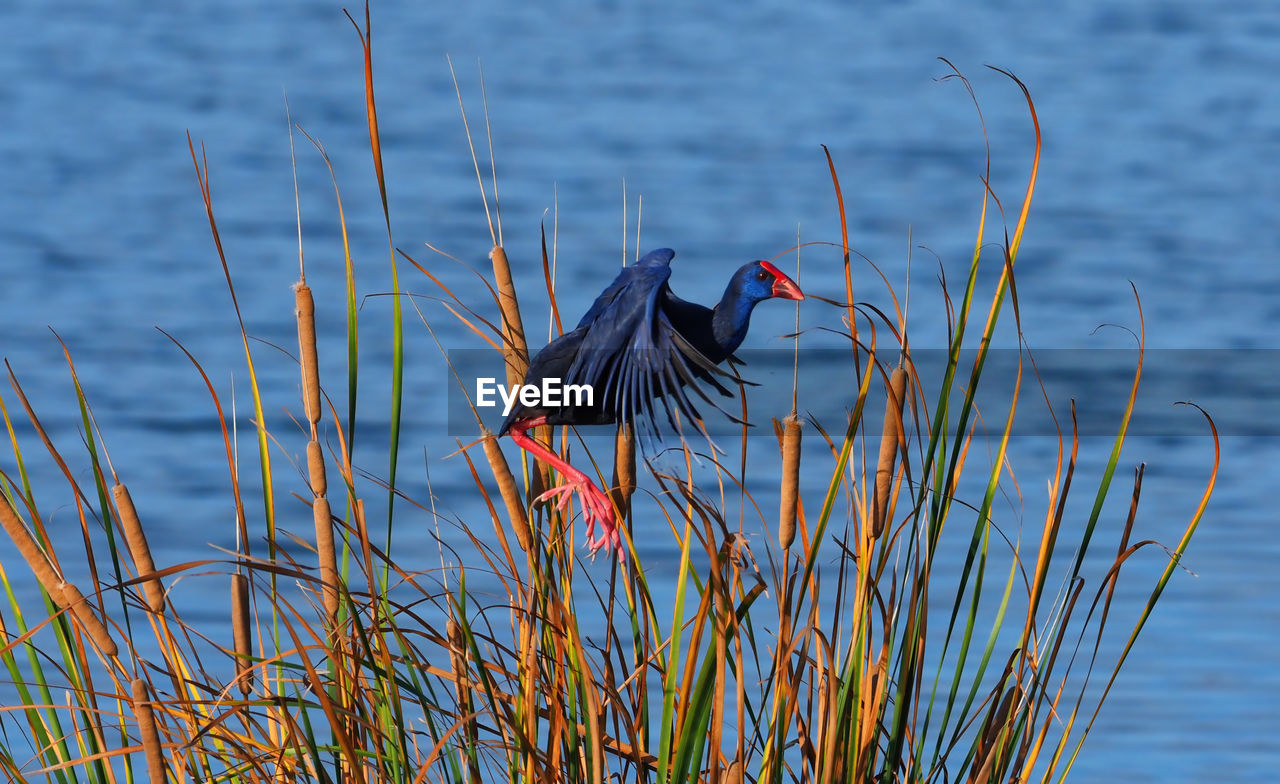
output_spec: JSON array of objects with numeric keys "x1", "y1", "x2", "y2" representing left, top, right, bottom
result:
[{"x1": 498, "y1": 247, "x2": 805, "y2": 560}]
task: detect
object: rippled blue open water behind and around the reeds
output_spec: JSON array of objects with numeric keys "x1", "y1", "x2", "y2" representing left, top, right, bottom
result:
[{"x1": 0, "y1": 0, "x2": 1280, "y2": 783}]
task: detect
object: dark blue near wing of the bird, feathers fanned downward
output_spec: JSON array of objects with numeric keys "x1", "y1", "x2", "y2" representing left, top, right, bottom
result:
[{"x1": 564, "y1": 249, "x2": 739, "y2": 448}]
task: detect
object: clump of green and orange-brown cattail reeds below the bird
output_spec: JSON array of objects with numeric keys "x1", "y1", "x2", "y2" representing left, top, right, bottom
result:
[{"x1": 0, "y1": 15, "x2": 1216, "y2": 783}]
